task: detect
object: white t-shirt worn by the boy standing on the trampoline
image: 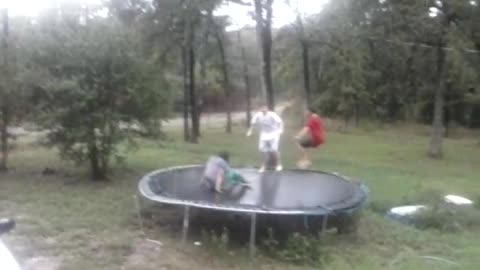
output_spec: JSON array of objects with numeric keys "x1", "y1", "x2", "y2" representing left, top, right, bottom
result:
[{"x1": 252, "y1": 111, "x2": 283, "y2": 141}]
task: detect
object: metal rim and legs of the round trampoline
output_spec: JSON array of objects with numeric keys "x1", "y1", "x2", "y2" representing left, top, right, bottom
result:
[{"x1": 138, "y1": 165, "x2": 368, "y2": 259}]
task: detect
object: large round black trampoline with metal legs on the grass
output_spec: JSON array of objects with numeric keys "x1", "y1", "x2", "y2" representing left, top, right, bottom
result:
[{"x1": 138, "y1": 165, "x2": 367, "y2": 255}]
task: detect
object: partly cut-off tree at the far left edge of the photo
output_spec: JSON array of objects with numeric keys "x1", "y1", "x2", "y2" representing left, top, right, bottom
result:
[{"x1": 0, "y1": 10, "x2": 45, "y2": 171}]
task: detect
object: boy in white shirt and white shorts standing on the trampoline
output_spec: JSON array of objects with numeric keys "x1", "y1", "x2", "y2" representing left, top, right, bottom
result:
[{"x1": 247, "y1": 106, "x2": 283, "y2": 172}]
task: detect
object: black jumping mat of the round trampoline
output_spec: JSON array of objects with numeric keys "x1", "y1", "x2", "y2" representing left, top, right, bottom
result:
[{"x1": 139, "y1": 166, "x2": 365, "y2": 214}]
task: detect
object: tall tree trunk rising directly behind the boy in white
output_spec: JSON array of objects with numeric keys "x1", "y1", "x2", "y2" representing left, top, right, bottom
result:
[{"x1": 255, "y1": 0, "x2": 275, "y2": 110}]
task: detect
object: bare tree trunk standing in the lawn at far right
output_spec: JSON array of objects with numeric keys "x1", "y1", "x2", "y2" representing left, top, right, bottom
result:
[{"x1": 428, "y1": 42, "x2": 446, "y2": 158}]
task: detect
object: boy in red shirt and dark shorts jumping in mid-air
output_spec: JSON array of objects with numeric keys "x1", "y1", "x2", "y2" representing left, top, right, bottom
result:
[{"x1": 295, "y1": 108, "x2": 325, "y2": 168}]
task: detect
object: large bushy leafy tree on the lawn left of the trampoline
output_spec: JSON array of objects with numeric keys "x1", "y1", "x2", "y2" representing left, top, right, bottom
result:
[{"x1": 36, "y1": 10, "x2": 170, "y2": 180}]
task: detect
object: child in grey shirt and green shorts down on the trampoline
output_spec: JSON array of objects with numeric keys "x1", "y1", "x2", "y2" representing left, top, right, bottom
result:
[{"x1": 201, "y1": 152, "x2": 249, "y2": 193}]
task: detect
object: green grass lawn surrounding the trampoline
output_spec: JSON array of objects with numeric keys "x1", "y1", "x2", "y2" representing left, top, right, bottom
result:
[{"x1": 0, "y1": 127, "x2": 480, "y2": 270}]
